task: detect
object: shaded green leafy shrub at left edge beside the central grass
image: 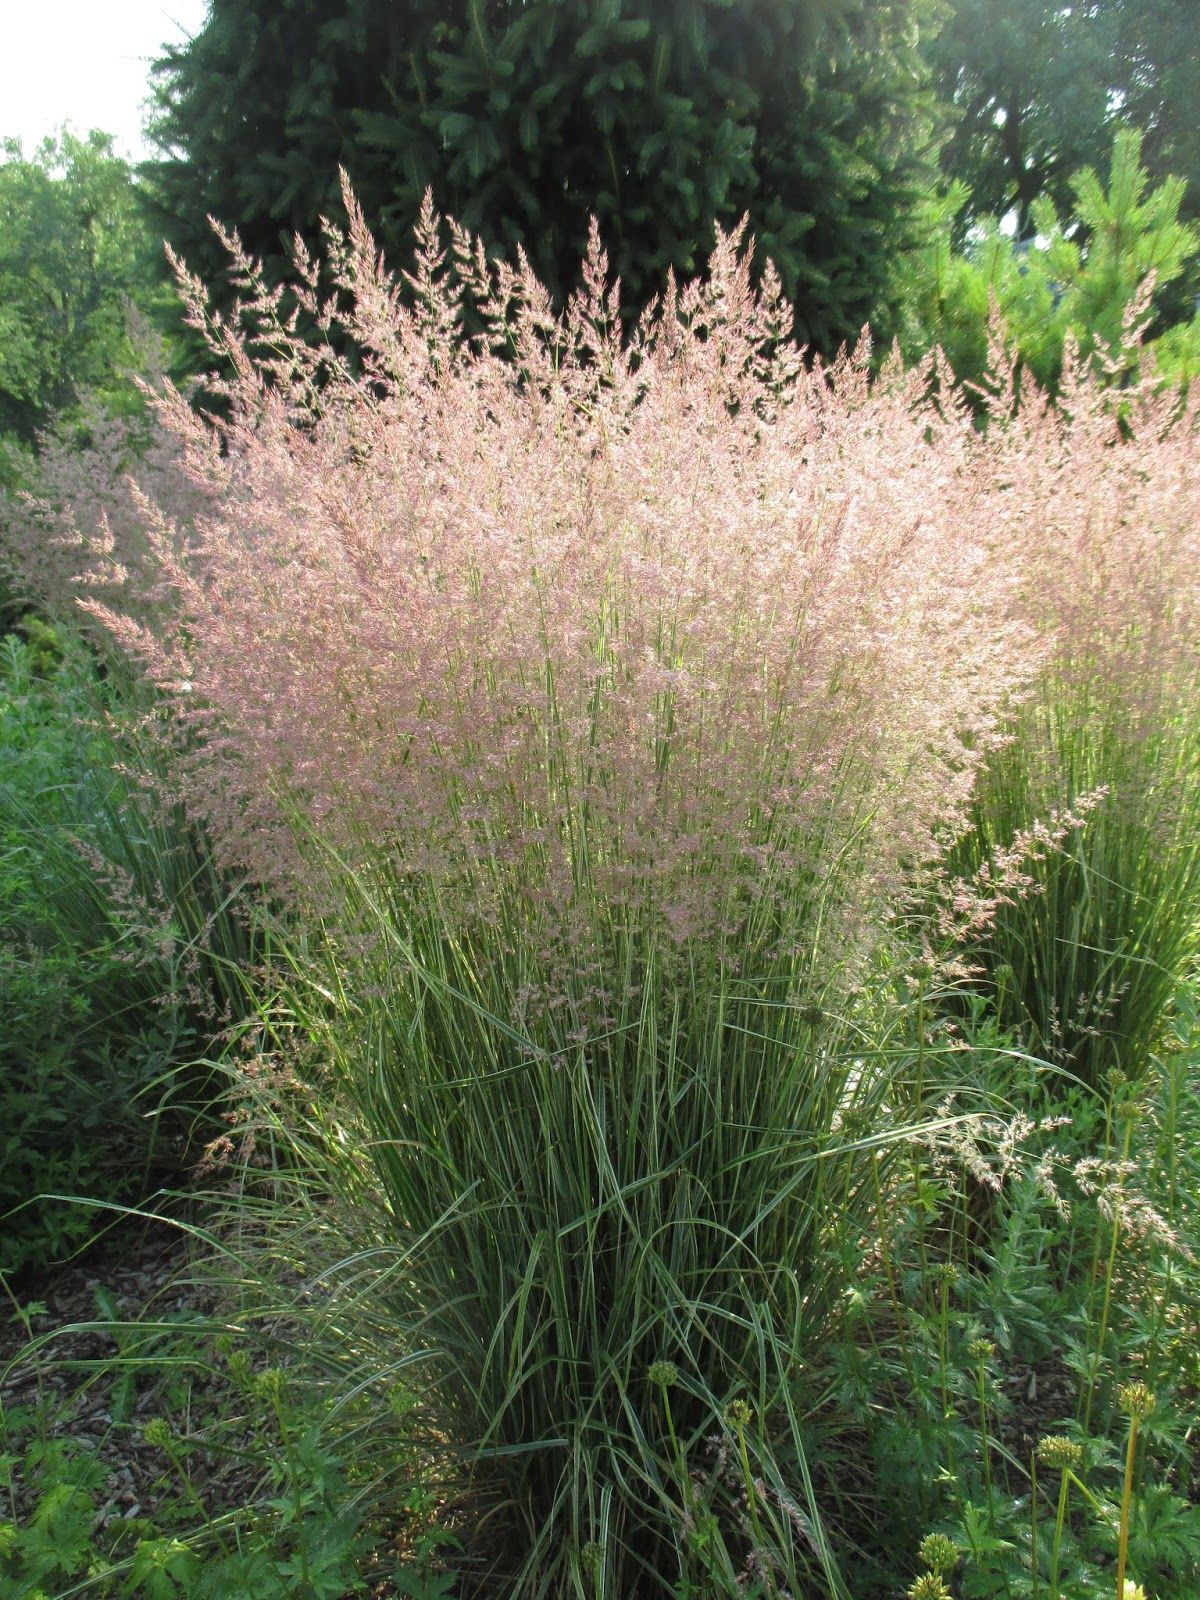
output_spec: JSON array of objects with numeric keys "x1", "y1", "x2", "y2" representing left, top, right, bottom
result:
[{"x1": 0, "y1": 622, "x2": 251, "y2": 1272}]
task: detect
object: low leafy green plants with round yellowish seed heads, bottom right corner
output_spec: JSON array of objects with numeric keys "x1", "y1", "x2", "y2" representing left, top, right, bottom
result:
[{"x1": 827, "y1": 987, "x2": 1200, "y2": 1600}]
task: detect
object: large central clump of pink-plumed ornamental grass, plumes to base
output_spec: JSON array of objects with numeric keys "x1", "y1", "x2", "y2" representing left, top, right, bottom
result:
[{"x1": 72, "y1": 181, "x2": 1037, "y2": 1597}]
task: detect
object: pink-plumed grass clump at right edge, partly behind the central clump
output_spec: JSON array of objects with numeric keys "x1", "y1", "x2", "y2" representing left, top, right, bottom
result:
[{"x1": 955, "y1": 329, "x2": 1200, "y2": 1088}]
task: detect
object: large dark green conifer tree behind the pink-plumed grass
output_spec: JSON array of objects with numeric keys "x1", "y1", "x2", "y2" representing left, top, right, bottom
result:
[{"x1": 147, "y1": 0, "x2": 938, "y2": 349}]
